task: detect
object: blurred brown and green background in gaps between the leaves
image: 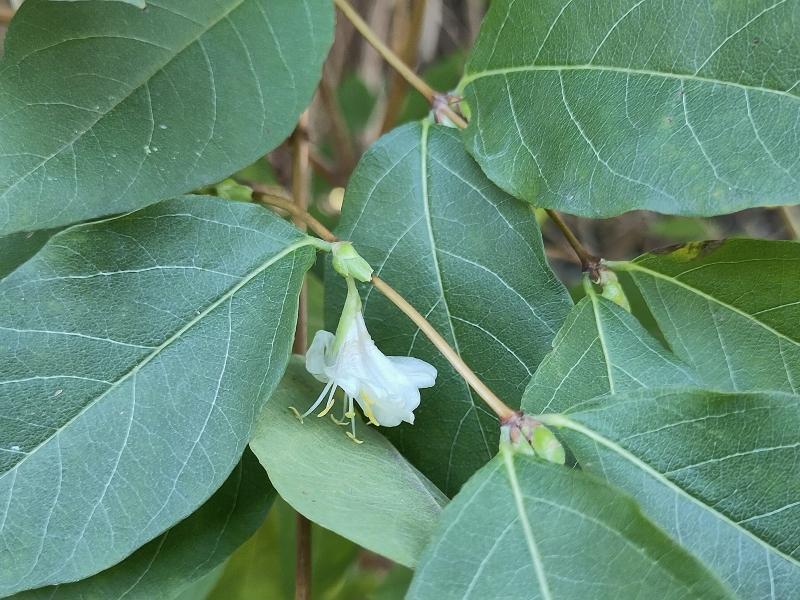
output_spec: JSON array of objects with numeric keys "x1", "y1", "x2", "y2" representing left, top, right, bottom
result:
[{"x1": 0, "y1": 0, "x2": 800, "y2": 600}]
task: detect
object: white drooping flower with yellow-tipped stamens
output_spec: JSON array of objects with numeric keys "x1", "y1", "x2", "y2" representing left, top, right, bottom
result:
[{"x1": 302, "y1": 277, "x2": 436, "y2": 439}]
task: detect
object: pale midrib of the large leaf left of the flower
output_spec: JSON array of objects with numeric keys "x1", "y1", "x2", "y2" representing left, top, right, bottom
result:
[{"x1": 0, "y1": 237, "x2": 314, "y2": 481}]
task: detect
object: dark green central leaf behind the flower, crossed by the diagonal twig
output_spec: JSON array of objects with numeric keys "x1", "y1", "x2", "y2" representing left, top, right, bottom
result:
[{"x1": 327, "y1": 123, "x2": 571, "y2": 495}]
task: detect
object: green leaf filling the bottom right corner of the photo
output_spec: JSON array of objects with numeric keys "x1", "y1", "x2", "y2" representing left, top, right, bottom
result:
[{"x1": 546, "y1": 390, "x2": 800, "y2": 600}]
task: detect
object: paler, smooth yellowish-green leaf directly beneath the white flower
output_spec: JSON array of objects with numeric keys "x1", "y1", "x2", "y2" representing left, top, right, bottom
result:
[{"x1": 250, "y1": 357, "x2": 447, "y2": 567}]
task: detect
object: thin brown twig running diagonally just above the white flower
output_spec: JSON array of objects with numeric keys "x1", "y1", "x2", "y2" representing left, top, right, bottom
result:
[{"x1": 256, "y1": 193, "x2": 518, "y2": 422}]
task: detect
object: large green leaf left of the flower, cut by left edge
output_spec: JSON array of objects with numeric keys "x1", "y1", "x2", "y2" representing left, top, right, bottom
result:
[{"x1": 0, "y1": 197, "x2": 314, "y2": 595}]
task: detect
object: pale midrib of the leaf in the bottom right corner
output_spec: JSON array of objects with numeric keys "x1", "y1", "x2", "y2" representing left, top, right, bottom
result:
[{"x1": 539, "y1": 415, "x2": 800, "y2": 567}]
